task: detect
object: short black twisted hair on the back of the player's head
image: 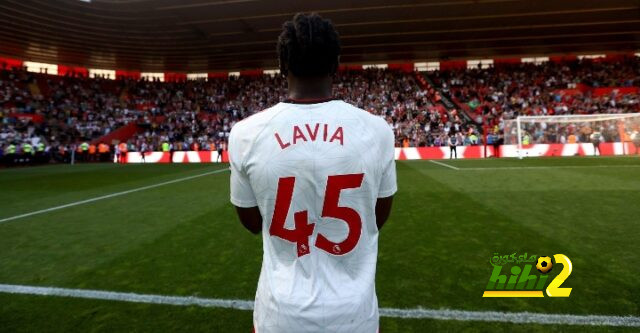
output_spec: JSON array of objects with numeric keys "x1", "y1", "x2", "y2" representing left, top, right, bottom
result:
[{"x1": 277, "y1": 13, "x2": 340, "y2": 77}]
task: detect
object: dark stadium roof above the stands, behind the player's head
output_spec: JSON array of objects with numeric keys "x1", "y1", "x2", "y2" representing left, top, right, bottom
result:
[{"x1": 0, "y1": 0, "x2": 640, "y2": 72}]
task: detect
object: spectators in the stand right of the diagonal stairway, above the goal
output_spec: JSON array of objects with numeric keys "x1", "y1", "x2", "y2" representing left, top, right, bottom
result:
[{"x1": 432, "y1": 57, "x2": 640, "y2": 142}]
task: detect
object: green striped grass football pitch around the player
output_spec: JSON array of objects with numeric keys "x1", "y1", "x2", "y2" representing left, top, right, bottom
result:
[{"x1": 0, "y1": 157, "x2": 640, "y2": 333}]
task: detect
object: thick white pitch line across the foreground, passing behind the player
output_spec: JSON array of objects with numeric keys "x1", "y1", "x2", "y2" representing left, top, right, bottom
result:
[{"x1": 0, "y1": 284, "x2": 640, "y2": 327}]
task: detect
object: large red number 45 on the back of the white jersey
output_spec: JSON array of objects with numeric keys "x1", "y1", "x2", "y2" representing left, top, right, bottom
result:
[{"x1": 269, "y1": 173, "x2": 364, "y2": 257}]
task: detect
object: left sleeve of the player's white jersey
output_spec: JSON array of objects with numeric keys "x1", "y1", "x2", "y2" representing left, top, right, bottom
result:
[{"x1": 228, "y1": 120, "x2": 258, "y2": 208}]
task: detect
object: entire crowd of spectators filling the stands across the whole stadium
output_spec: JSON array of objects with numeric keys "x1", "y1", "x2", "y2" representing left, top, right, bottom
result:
[{"x1": 0, "y1": 57, "x2": 640, "y2": 163}]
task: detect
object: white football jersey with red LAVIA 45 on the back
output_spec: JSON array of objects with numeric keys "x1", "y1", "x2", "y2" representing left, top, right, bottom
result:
[{"x1": 229, "y1": 100, "x2": 397, "y2": 333}]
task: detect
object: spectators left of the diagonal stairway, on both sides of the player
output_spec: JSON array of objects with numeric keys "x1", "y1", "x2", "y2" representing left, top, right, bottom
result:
[{"x1": 0, "y1": 65, "x2": 456, "y2": 162}]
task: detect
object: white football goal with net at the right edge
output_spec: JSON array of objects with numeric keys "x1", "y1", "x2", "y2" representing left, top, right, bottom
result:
[{"x1": 504, "y1": 113, "x2": 640, "y2": 158}]
